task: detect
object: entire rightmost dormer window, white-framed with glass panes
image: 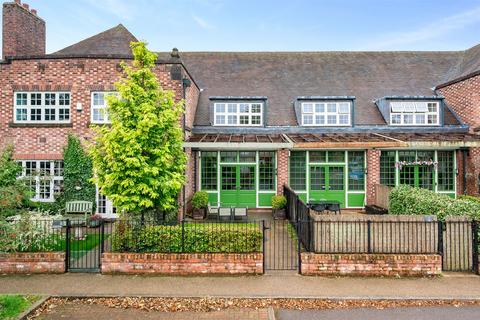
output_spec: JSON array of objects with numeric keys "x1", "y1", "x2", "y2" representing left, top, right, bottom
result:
[{"x1": 390, "y1": 101, "x2": 440, "y2": 126}]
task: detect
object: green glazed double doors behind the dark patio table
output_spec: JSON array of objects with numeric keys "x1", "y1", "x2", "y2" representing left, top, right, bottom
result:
[{"x1": 310, "y1": 166, "x2": 345, "y2": 208}]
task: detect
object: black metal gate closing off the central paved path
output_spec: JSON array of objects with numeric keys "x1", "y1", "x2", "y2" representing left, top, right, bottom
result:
[{"x1": 263, "y1": 220, "x2": 299, "y2": 271}]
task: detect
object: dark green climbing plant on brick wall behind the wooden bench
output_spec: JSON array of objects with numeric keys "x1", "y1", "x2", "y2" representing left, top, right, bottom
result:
[{"x1": 61, "y1": 134, "x2": 96, "y2": 209}]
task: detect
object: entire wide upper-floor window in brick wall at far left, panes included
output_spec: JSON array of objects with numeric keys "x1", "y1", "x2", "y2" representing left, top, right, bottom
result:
[{"x1": 13, "y1": 92, "x2": 71, "y2": 123}]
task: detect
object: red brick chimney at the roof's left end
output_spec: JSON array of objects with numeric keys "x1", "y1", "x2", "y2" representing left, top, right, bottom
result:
[{"x1": 2, "y1": 0, "x2": 45, "y2": 58}]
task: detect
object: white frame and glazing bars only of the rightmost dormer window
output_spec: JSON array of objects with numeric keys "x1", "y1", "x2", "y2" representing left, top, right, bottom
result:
[{"x1": 388, "y1": 101, "x2": 440, "y2": 126}]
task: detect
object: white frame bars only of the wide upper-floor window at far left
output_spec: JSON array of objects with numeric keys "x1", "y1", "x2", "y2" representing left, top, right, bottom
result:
[{"x1": 13, "y1": 91, "x2": 72, "y2": 124}]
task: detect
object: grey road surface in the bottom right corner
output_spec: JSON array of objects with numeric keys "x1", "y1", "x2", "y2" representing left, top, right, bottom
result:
[{"x1": 275, "y1": 306, "x2": 480, "y2": 320}]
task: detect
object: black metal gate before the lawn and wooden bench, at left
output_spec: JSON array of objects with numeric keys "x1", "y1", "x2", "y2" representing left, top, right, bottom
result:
[{"x1": 65, "y1": 219, "x2": 105, "y2": 272}]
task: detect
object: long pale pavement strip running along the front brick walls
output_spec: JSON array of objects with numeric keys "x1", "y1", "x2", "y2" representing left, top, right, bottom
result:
[{"x1": 0, "y1": 272, "x2": 480, "y2": 299}]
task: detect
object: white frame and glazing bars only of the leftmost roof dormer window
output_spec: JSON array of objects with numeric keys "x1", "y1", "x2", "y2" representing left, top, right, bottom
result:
[{"x1": 213, "y1": 101, "x2": 264, "y2": 127}]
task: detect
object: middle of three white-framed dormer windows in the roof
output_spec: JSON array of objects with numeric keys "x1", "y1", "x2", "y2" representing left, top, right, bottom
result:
[{"x1": 301, "y1": 101, "x2": 351, "y2": 126}]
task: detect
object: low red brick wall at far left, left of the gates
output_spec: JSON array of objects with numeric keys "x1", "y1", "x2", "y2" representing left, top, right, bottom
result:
[{"x1": 0, "y1": 252, "x2": 65, "y2": 273}]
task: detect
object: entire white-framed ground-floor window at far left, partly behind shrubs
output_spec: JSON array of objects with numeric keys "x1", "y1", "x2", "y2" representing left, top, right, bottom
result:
[{"x1": 17, "y1": 160, "x2": 63, "y2": 202}]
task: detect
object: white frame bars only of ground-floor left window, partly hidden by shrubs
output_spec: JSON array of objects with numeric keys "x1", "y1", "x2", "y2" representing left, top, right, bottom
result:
[{"x1": 17, "y1": 160, "x2": 64, "y2": 202}]
